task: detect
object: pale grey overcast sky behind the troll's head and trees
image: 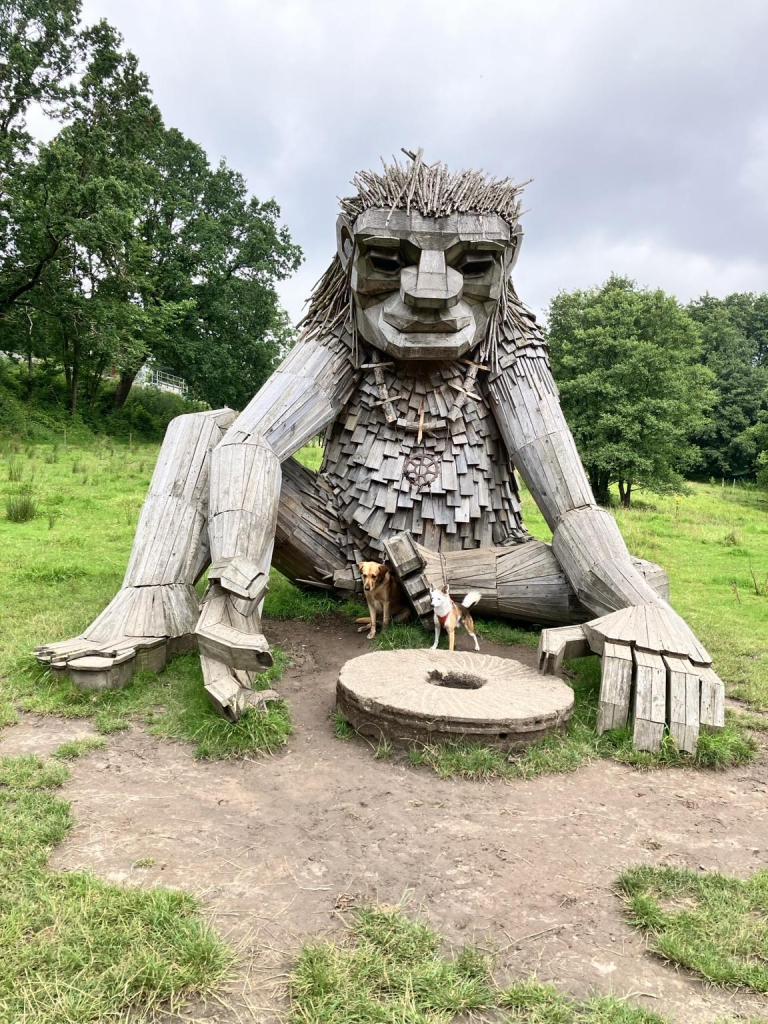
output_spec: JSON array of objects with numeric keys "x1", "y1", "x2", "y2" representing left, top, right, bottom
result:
[{"x1": 84, "y1": 0, "x2": 768, "y2": 318}]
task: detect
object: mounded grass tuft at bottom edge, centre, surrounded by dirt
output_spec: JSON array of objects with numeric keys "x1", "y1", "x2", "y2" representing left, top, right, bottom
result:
[{"x1": 290, "y1": 906, "x2": 495, "y2": 1024}]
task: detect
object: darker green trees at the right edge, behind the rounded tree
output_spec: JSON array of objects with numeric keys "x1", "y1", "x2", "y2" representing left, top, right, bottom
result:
[{"x1": 687, "y1": 294, "x2": 768, "y2": 476}]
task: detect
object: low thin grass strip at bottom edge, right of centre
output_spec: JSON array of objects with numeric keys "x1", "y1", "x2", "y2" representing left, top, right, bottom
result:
[{"x1": 499, "y1": 981, "x2": 669, "y2": 1024}]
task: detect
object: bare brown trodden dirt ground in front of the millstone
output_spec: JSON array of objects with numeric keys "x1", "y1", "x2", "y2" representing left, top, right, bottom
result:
[{"x1": 0, "y1": 620, "x2": 768, "y2": 1024}]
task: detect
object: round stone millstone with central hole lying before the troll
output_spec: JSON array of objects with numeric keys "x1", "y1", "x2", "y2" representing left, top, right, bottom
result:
[{"x1": 336, "y1": 650, "x2": 573, "y2": 751}]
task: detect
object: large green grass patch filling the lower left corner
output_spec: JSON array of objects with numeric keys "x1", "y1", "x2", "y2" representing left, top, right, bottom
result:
[{"x1": 0, "y1": 741, "x2": 232, "y2": 1024}]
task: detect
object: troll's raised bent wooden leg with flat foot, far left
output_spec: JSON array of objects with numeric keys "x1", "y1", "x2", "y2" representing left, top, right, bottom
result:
[{"x1": 36, "y1": 409, "x2": 236, "y2": 689}]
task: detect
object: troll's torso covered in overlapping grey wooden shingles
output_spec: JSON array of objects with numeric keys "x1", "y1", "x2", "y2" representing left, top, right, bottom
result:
[{"x1": 321, "y1": 353, "x2": 527, "y2": 559}]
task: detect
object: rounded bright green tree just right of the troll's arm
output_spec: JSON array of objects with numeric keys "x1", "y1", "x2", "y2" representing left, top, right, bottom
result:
[{"x1": 549, "y1": 276, "x2": 713, "y2": 506}]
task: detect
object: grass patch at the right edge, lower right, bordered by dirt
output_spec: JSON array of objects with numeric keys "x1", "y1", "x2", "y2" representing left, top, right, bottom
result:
[{"x1": 618, "y1": 864, "x2": 768, "y2": 992}]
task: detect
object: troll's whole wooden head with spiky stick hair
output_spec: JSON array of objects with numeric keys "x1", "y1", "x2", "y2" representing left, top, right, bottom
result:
[{"x1": 305, "y1": 151, "x2": 522, "y2": 359}]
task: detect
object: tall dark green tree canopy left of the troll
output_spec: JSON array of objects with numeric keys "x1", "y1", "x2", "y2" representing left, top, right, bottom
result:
[{"x1": 0, "y1": 0, "x2": 301, "y2": 412}]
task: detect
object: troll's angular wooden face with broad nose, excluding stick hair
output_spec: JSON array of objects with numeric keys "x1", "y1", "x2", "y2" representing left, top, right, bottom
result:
[{"x1": 338, "y1": 209, "x2": 521, "y2": 359}]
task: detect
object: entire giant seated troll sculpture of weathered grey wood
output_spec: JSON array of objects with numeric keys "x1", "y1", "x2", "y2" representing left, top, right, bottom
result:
[{"x1": 37, "y1": 154, "x2": 723, "y2": 751}]
